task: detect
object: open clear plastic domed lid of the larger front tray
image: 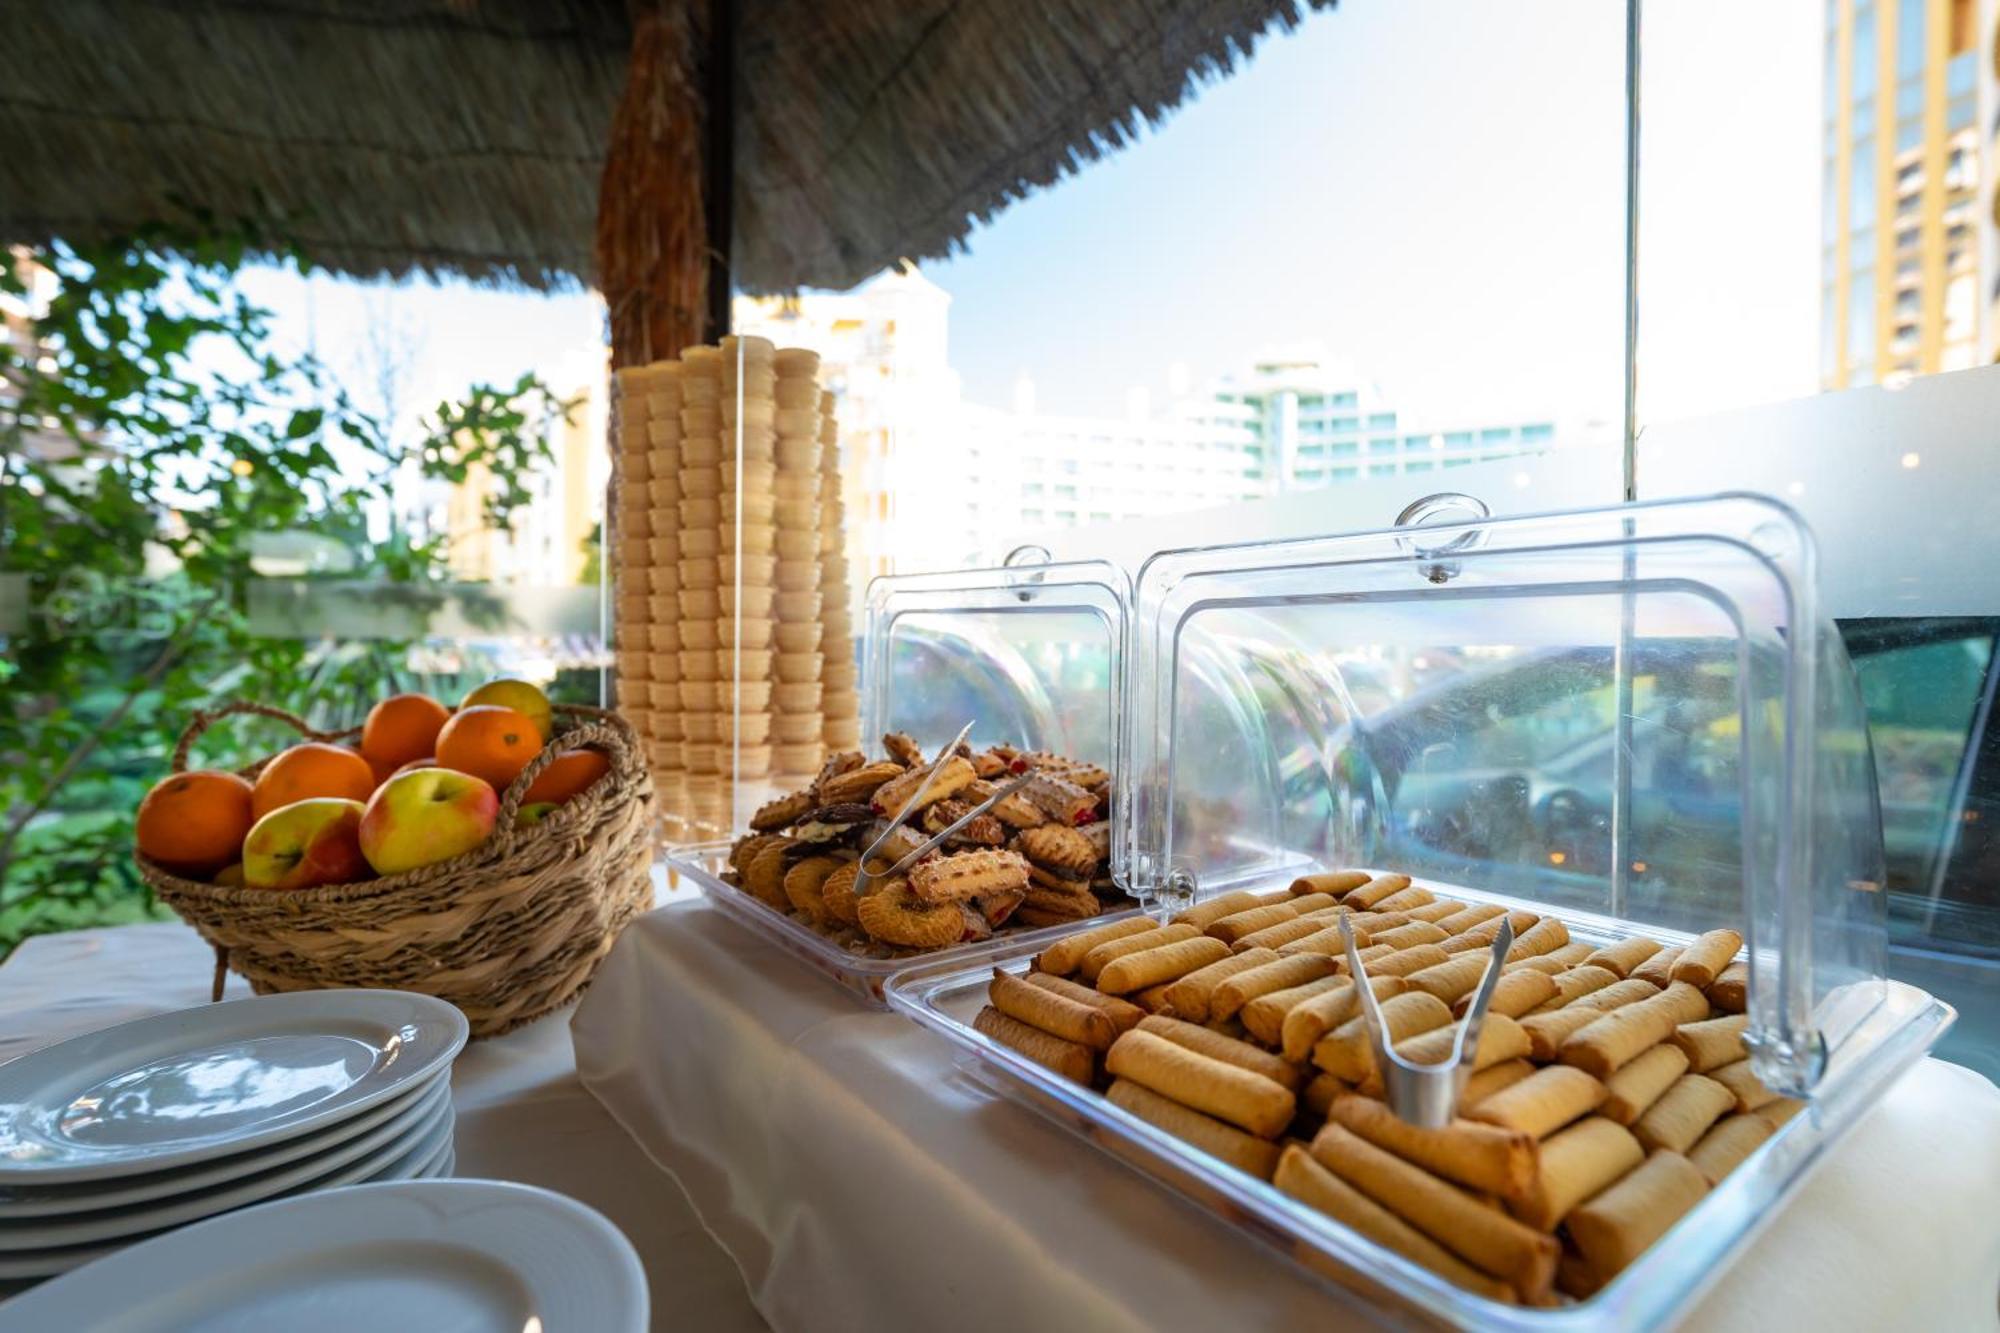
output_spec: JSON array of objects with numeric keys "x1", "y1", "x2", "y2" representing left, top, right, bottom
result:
[{"x1": 1116, "y1": 496, "x2": 1886, "y2": 1091}]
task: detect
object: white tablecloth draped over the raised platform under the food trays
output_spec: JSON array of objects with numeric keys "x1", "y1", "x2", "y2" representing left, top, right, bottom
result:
[{"x1": 570, "y1": 903, "x2": 2000, "y2": 1333}]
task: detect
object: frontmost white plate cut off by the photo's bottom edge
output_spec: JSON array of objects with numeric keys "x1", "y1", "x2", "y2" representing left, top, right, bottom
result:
[{"x1": 0, "y1": 1181, "x2": 646, "y2": 1333}]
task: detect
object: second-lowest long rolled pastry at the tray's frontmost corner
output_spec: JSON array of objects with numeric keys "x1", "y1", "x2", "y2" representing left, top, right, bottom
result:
[{"x1": 1310, "y1": 1123, "x2": 1560, "y2": 1301}]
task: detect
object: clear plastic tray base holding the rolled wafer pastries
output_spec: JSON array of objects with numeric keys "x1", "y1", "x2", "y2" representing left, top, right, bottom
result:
[{"x1": 888, "y1": 879, "x2": 1956, "y2": 1333}]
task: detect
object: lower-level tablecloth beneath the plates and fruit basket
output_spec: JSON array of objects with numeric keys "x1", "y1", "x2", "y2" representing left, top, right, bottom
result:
[{"x1": 0, "y1": 912, "x2": 764, "y2": 1333}]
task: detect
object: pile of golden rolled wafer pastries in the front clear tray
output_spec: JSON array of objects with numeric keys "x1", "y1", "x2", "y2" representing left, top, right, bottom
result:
[{"x1": 974, "y1": 871, "x2": 1802, "y2": 1305}]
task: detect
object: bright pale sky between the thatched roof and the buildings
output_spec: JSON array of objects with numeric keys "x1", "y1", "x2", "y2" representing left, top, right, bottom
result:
[{"x1": 230, "y1": 0, "x2": 1820, "y2": 440}]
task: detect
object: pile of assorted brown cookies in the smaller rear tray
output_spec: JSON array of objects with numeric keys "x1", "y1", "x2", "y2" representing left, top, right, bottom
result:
[{"x1": 728, "y1": 733, "x2": 1122, "y2": 957}]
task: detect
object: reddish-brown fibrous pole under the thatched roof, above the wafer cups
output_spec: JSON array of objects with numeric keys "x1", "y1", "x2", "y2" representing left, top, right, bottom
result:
[{"x1": 596, "y1": 0, "x2": 712, "y2": 366}]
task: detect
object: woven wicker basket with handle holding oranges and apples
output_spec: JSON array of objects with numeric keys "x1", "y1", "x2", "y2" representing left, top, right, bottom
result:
[{"x1": 138, "y1": 703, "x2": 654, "y2": 1037}]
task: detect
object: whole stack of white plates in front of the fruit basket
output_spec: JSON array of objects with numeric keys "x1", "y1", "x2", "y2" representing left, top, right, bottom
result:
[{"x1": 0, "y1": 991, "x2": 466, "y2": 1279}]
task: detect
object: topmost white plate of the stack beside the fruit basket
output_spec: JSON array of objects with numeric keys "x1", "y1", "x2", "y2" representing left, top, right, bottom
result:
[{"x1": 0, "y1": 991, "x2": 466, "y2": 1187}]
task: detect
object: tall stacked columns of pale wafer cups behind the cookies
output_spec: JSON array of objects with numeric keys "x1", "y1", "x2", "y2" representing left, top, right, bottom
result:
[{"x1": 612, "y1": 338, "x2": 860, "y2": 837}]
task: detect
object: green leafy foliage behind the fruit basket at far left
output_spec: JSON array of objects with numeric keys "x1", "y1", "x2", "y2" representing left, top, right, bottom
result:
[{"x1": 0, "y1": 228, "x2": 572, "y2": 951}]
